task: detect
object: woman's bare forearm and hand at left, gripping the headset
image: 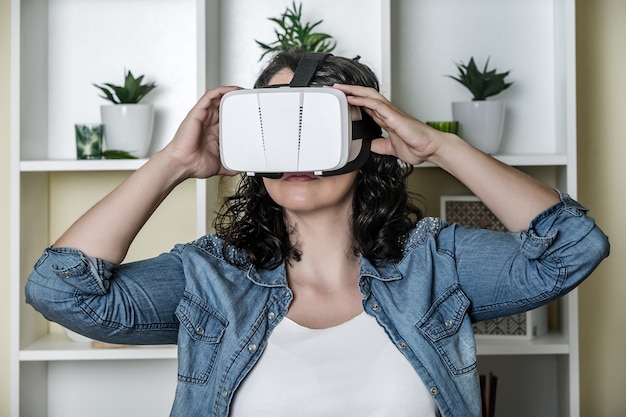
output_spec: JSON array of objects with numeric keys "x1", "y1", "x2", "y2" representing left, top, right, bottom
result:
[{"x1": 54, "y1": 87, "x2": 239, "y2": 263}]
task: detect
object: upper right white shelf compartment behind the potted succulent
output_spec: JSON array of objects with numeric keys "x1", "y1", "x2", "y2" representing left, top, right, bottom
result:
[{"x1": 391, "y1": 0, "x2": 575, "y2": 158}]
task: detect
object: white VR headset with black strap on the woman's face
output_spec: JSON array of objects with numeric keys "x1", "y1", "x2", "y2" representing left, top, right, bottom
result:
[{"x1": 219, "y1": 53, "x2": 382, "y2": 178}]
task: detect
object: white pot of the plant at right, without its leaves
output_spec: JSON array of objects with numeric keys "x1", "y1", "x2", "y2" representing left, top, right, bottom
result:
[{"x1": 452, "y1": 100, "x2": 504, "y2": 154}]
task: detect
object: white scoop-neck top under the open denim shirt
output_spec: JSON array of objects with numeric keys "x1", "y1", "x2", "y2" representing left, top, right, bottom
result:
[{"x1": 229, "y1": 312, "x2": 438, "y2": 417}]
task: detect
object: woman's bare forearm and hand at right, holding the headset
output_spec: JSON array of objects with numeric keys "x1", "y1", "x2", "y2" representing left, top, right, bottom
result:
[{"x1": 334, "y1": 85, "x2": 559, "y2": 231}]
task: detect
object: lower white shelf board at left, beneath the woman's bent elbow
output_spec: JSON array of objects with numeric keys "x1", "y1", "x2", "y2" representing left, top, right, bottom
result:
[{"x1": 19, "y1": 334, "x2": 177, "y2": 362}]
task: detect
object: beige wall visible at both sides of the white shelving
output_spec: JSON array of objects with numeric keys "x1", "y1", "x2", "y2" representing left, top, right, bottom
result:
[{"x1": 0, "y1": 0, "x2": 626, "y2": 417}]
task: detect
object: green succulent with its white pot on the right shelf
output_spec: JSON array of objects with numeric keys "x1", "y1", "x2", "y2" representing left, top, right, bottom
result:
[{"x1": 448, "y1": 57, "x2": 513, "y2": 154}]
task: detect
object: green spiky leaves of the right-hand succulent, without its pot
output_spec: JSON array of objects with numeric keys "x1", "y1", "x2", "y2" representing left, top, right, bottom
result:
[{"x1": 448, "y1": 57, "x2": 513, "y2": 100}]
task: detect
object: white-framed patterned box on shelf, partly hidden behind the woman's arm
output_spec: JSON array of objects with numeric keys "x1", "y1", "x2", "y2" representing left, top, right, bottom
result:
[{"x1": 441, "y1": 195, "x2": 548, "y2": 340}]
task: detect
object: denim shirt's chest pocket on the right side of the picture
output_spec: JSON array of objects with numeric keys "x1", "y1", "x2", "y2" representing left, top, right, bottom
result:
[{"x1": 417, "y1": 285, "x2": 476, "y2": 376}]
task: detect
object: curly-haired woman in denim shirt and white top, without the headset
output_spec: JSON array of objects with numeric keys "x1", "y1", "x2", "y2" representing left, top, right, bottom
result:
[{"x1": 26, "y1": 52, "x2": 609, "y2": 416}]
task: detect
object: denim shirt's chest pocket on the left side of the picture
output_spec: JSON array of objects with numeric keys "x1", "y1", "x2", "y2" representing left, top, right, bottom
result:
[{"x1": 176, "y1": 293, "x2": 228, "y2": 384}]
